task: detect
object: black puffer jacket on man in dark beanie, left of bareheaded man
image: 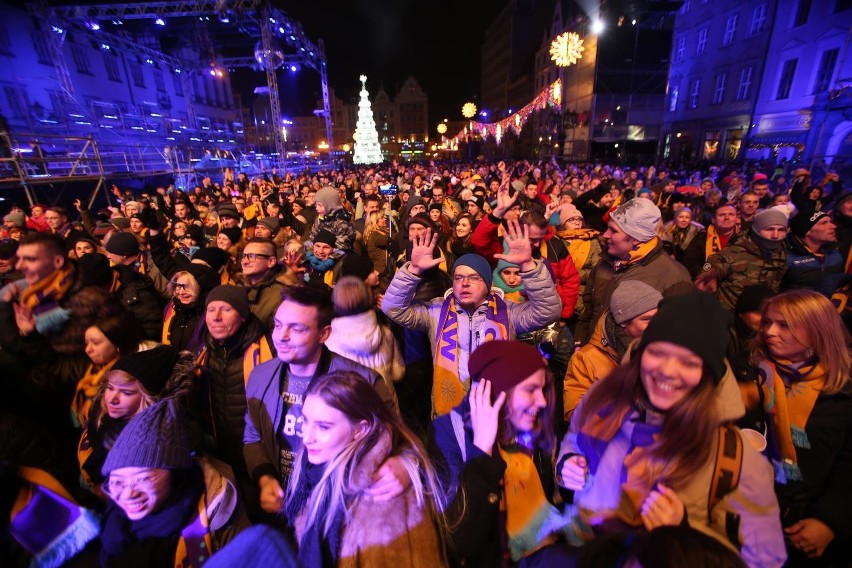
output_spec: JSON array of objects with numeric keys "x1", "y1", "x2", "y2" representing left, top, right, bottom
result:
[{"x1": 201, "y1": 314, "x2": 265, "y2": 476}]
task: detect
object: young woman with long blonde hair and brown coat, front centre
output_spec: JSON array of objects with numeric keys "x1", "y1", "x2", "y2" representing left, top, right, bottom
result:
[{"x1": 285, "y1": 371, "x2": 446, "y2": 568}]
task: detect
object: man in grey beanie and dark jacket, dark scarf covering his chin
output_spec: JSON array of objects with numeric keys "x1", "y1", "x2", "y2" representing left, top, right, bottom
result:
[{"x1": 695, "y1": 207, "x2": 787, "y2": 311}]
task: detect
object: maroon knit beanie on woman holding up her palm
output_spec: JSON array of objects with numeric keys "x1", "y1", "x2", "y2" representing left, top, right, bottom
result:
[{"x1": 467, "y1": 340, "x2": 547, "y2": 399}]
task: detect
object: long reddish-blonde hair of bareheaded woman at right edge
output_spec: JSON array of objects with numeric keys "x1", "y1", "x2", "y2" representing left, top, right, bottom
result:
[{"x1": 751, "y1": 290, "x2": 852, "y2": 394}]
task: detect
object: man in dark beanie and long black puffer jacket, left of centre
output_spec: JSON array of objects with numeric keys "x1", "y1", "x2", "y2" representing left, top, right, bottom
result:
[{"x1": 199, "y1": 285, "x2": 273, "y2": 511}]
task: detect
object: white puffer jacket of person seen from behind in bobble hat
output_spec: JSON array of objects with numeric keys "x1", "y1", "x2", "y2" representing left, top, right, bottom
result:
[{"x1": 325, "y1": 310, "x2": 405, "y2": 410}]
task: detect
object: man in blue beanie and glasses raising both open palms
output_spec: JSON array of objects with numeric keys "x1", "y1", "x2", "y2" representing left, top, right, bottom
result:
[{"x1": 382, "y1": 221, "x2": 562, "y2": 415}]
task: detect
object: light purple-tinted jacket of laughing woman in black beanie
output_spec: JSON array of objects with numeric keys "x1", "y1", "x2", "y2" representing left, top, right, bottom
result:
[{"x1": 557, "y1": 369, "x2": 787, "y2": 568}]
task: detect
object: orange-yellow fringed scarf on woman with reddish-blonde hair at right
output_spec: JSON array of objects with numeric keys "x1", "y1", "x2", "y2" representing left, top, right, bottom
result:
[{"x1": 758, "y1": 357, "x2": 825, "y2": 484}]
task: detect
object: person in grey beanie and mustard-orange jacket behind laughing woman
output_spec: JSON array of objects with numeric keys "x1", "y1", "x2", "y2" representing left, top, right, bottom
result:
[{"x1": 565, "y1": 280, "x2": 663, "y2": 422}]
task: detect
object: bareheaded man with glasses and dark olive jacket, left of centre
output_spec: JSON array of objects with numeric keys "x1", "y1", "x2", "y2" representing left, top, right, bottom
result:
[{"x1": 240, "y1": 238, "x2": 296, "y2": 329}]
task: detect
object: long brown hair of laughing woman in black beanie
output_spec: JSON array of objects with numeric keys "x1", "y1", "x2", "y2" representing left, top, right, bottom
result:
[{"x1": 572, "y1": 349, "x2": 719, "y2": 488}]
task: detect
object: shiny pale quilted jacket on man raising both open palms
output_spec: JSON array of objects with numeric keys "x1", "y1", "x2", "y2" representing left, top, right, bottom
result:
[{"x1": 382, "y1": 261, "x2": 562, "y2": 389}]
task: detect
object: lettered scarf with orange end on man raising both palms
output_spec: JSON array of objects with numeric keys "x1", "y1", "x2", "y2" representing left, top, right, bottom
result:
[{"x1": 432, "y1": 292, "x2": 509, "y2": 416}]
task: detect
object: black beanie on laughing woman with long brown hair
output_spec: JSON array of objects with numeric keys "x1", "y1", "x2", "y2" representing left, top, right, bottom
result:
[{"x1": 639, "y1": 292, "x2": 731, "y2": 384}]
